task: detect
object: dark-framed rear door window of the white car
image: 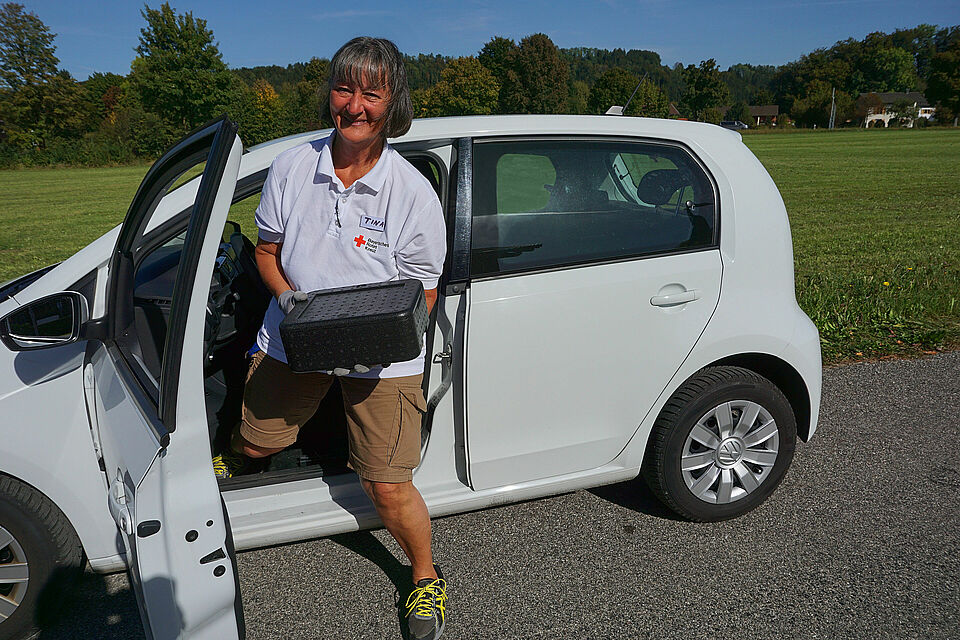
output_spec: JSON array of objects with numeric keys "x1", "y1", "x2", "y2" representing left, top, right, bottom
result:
[{"x1": 471, "y1": 140, "x2": 717, "y2": 277}]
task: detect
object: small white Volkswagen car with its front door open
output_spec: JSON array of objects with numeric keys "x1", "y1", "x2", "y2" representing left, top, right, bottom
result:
[{"x1": 0, "y1": 116, "x2": 821, "y2": 639}]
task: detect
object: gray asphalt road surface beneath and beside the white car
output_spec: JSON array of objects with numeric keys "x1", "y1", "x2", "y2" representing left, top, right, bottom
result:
[{"x1": 33, "y1": 353, "x2": 960, "y2": 640}]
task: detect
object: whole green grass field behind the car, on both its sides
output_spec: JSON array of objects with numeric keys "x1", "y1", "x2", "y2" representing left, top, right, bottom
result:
[{"x1": 0, "y1": 129, "x2": 960, "y2": 362}]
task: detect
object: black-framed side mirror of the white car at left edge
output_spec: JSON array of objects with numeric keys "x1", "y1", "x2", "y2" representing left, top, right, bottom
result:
[{"x1": 0, "y1": 291, "x2": 90, "y2": 351}]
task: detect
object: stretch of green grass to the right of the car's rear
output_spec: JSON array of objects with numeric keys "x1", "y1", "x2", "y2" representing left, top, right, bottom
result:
[{"x1": 744, "y1": 129, "x2": 960, "y2": 362}]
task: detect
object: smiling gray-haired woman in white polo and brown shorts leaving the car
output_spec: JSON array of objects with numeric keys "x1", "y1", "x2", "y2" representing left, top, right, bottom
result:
[{"x1": 215, "y1": 37, "x2": 446, "y2": 639}]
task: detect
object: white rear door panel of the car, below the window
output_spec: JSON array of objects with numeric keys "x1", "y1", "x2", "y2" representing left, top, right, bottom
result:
[{"x1": 466, "y1": 250, "x2": 721, "y2": 490}]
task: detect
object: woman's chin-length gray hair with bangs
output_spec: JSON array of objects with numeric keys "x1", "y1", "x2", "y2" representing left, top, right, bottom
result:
[{"x1": 329, "y1": 36, "x2": 413, "y2": 138}]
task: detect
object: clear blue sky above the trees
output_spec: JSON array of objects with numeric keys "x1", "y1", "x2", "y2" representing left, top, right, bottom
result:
[{"x1": 26, "y1": 0, "x2": 960, "y2": 80}]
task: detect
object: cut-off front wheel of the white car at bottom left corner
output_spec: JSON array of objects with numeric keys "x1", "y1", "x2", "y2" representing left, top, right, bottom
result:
[{"x1": 0, "y1": 476, "x2": 83, "y2": 640}]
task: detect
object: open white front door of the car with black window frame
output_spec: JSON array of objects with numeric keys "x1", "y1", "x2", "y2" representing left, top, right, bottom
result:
[{"x1": 84, "y1": 118, "x2": 243, "y2": 639}]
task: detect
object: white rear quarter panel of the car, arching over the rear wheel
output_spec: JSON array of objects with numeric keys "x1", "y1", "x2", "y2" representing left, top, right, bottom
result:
[{"x1": 618, "y1": 139, "x2": 822, "y2": 466}]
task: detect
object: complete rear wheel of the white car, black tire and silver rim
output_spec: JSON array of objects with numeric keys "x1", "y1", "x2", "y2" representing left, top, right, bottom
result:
[{"x1": 644, "y1": 367, "x2": 797, "y2": 522}]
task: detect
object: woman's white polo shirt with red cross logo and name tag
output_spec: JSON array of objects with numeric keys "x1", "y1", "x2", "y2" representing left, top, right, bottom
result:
[{"x1": 256, "y1": 133, "x2": 446, "y2": 378}]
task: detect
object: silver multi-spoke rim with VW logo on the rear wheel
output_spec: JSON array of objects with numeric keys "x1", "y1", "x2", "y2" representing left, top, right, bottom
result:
[{"x1": 680, "y1": 400, "x2": 780, "y2": 504}]
